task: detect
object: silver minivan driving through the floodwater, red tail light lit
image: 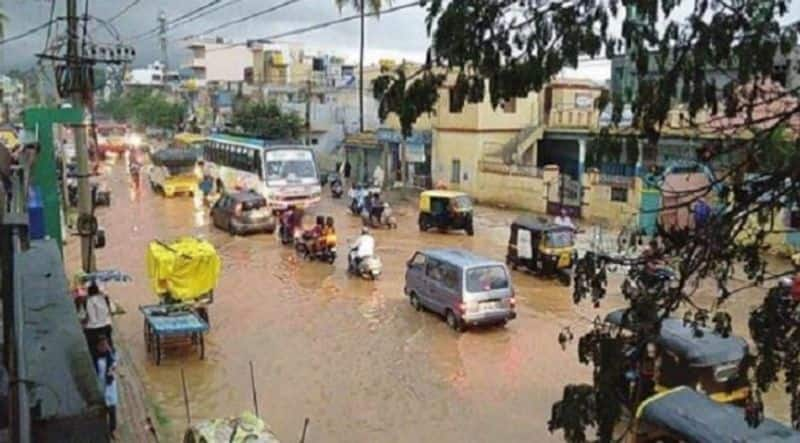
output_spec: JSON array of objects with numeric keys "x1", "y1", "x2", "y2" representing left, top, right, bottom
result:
[{"x1": 404, "y1": 249, "x2": 517, "y2": 331}]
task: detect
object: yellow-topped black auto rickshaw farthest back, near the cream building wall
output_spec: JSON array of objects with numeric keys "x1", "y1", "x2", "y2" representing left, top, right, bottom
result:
[{"x1": 419, "y1": 191, "x2": 475, "y2": 236}]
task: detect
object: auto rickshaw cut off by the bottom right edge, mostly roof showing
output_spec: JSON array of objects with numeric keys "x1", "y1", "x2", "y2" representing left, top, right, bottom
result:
[{"x1": 624, "y1": 386, "x2": 800, "y2": 443}]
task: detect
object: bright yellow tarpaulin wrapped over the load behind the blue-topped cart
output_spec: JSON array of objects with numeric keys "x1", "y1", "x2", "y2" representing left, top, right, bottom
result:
[{"x1": 147, "y1": 237, "x2": 221, "y2": 301}]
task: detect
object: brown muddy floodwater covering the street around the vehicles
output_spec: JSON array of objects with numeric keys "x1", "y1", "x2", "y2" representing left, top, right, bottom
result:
[{"x1": 67, "y1": 168, "x2": 786, "y2": 443}]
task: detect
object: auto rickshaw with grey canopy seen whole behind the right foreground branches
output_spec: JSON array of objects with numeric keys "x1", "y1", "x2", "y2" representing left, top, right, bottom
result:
[{"x1": 605, "y1": 309, "x2": 750, "y2": 404}]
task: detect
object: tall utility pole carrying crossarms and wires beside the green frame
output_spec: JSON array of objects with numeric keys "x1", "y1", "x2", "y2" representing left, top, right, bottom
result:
[{"x1": 67, "y1": 0, "x2": 95, "y2": 272}]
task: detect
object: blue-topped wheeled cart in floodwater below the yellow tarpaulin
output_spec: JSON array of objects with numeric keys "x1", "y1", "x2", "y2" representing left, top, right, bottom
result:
[{"x1": 139, "y1": 304, "x2": 208, "y2": 365}]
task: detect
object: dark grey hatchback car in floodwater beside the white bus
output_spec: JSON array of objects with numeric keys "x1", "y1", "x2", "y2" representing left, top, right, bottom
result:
[{"x1": 211, "y1": 191, "x2": 275, "y2": 235}]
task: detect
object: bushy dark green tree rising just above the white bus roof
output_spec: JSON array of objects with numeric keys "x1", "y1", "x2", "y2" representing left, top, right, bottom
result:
[{"x1": 232, "y1": 101, "x2": 303, "y2": 139}]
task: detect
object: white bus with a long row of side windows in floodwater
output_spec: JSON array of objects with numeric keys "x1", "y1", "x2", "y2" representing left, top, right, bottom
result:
[{"x1": 203, "y1": 134, "x2": 322, "y2": 210}]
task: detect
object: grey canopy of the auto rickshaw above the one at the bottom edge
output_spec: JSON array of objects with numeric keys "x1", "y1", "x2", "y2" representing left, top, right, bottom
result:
[{"x1": 606, "y1": 309, "x2": 747, "y2": 368}]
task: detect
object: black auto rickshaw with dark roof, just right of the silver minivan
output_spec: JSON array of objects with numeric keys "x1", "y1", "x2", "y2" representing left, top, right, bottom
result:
[{"x1": 506, "y1": 215, "x2": 576, "y2": 286}]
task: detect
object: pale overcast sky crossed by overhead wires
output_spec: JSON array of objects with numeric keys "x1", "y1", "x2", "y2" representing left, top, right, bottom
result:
[{"x1": 0, "y1": 0, "x2": 800, "y2": 81}]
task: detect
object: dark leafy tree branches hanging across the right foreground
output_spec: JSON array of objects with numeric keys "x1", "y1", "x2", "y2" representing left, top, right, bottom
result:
[{"x1": 374, "y1": 0, "x2": 800, "y2": 441}]
